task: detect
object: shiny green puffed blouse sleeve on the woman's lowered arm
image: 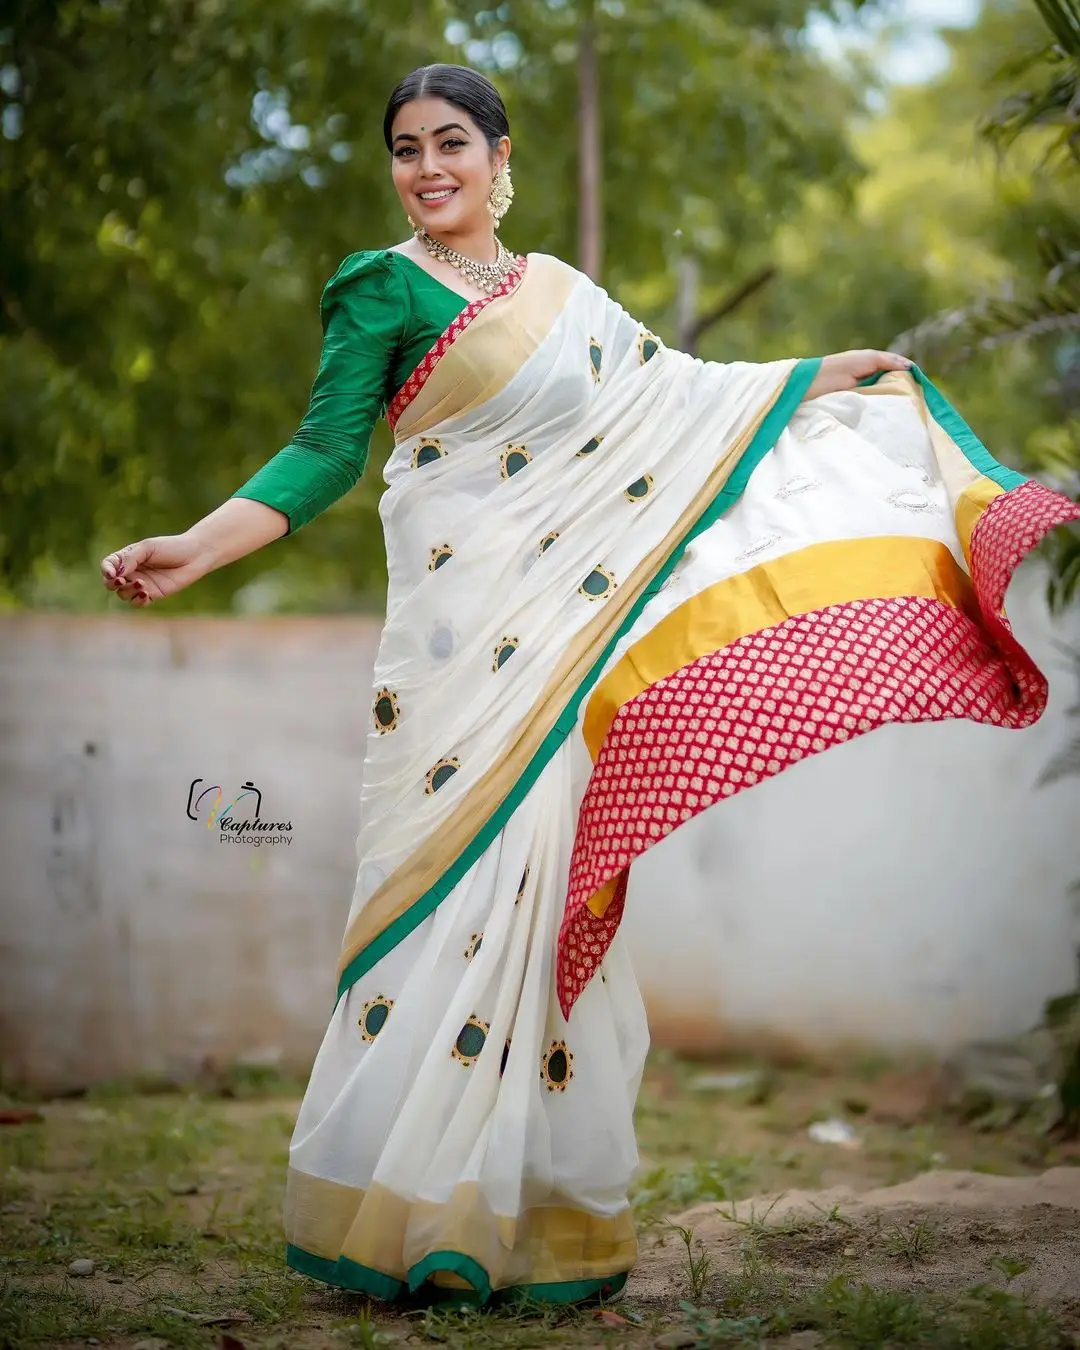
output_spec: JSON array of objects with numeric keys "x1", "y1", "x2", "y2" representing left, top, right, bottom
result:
[{"x1": 232, "y1": 252, "x2": 408, "y2": 535}]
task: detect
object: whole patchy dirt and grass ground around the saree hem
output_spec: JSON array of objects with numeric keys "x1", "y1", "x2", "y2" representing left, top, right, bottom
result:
[{"x1": 0, "y1": 1053, "x2": 1080, "y2": 1350}]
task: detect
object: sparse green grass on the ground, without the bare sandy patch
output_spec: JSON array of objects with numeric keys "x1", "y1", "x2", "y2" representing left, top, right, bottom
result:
[{"x1": 0, "y1": 1054, "x2": 1075, "y2": 1350}]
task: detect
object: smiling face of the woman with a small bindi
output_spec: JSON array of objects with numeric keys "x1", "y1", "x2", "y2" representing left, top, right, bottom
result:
[{"x1": 390, "y1": 99, "x2": 510, "y2": 234}]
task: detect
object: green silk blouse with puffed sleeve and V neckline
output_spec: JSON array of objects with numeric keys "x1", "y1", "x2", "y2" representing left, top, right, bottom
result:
[{"x1": 232, "y1": 248, "x2": 468, "y2": 535}]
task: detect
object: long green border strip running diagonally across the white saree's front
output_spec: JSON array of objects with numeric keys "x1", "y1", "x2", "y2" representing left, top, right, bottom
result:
[{"x1": 338, "y1": 356, "x2": 822, "y2": 999}]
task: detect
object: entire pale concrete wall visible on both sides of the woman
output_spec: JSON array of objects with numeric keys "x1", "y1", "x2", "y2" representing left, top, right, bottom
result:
[{"x1": 0, "y1": 566, "x2": 1080, "y2": 1089}]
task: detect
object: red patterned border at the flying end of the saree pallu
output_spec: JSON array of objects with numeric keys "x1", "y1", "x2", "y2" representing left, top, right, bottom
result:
[{"x1": 556, "y1": 481, "x2": 1080, "y2": 1018}]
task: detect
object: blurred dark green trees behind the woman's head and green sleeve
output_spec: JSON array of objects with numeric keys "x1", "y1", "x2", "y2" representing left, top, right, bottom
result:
[{"x1": 0, "y1": 0, "x2": 857, "y2": 613}]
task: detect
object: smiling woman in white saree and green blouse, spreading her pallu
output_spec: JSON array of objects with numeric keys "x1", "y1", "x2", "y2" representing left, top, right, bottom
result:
[{"x1": 101, "y1": 66, "x2": 1077, "y2": 1301}]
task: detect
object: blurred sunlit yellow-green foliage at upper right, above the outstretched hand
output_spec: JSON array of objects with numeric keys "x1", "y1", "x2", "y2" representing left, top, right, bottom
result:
[{"x1": 702, "y1": 0, "x2": 1080, "y2": 553}]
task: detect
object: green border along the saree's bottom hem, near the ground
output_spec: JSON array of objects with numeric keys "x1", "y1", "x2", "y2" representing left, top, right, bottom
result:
[{"x1": 285, "y1": 1242, "x2": 629, "y2": 1304}]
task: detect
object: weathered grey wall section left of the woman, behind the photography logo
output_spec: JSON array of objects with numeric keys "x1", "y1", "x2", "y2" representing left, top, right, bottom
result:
[{"x1": 0, "y1": 613, "x2": 378, "y2": 1088}]
